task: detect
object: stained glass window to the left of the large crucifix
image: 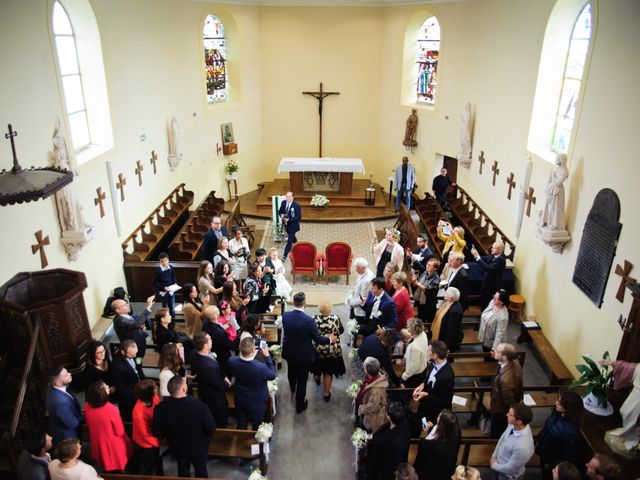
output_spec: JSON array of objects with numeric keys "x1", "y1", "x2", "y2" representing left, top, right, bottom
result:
[{"x1": 203, "y1": 15, "x2": 227, "y2": 103}]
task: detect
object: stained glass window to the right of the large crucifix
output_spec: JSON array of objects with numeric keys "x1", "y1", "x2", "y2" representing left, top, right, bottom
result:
[{"x1": 416, "y1": 17, "x2": 440, "y2": 105}]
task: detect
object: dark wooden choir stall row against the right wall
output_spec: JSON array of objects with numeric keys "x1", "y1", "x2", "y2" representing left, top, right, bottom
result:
[{"x1": 447, "y1": 185, "x2": 516, "y2": 262}]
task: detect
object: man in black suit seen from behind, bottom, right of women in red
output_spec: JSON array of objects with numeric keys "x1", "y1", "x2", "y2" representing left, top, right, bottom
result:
[{"x1": 153, "y1": 375, "x2": 216, "y2": 478}]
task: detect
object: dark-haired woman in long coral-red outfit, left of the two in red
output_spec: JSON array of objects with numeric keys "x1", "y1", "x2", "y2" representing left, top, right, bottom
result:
[{"x1": 84, "y1": 381, "x2": 132, "y2": 473}]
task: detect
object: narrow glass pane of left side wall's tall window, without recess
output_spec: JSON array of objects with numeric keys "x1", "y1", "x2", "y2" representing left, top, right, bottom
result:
[{"x1": 52, "y1": 2, "x2": 91, "y2": 151}]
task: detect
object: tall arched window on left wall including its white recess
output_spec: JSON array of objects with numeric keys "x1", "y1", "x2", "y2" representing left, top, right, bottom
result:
[{"x1": 51, "y1": 0, "x2": 113, "y2": 164}]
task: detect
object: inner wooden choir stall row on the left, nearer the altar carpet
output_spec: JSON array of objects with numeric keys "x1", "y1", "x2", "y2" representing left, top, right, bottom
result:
[{"x1": 169, "y1": 190, "x2": 224, "y2": 260}]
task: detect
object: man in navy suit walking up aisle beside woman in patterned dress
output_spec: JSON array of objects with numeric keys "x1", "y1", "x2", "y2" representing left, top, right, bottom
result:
[{"x1": 282, "y1": 292, "x2": 338, "y2": 413}]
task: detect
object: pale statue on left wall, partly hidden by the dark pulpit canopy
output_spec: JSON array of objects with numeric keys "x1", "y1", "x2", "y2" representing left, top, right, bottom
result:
[{"x1": 50, "y1": 118, "x2": 94, "y2": 261}]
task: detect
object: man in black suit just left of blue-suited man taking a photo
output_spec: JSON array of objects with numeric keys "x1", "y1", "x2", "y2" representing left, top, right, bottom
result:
[{"x1": 191, "y1": 332, "x2": 231, "y2": 428}]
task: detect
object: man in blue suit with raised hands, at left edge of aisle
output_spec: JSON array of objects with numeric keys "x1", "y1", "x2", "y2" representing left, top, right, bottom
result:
[{"x1": 229, "y1": 337, "x2": 276, "y2": 430}]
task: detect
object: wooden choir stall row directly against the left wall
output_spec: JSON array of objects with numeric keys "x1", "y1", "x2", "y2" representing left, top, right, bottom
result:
[{"x1": 122, "y1": 183, "x2": 194, "y2": 261}]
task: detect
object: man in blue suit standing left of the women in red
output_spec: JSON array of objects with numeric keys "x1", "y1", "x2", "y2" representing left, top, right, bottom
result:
[{"x1": 45, "y1": 366, "x2": 83, "y2": 448}]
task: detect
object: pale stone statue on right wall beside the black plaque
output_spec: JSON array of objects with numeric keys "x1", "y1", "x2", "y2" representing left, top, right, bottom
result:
[{"x1": 538, "y1": 153, "x2": 571, "y2": 253}]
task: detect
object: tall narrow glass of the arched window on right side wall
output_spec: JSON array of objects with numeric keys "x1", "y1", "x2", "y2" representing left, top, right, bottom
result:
[{"x1": 551, "y1": 4, "x2": 591, "y2": 153}]
